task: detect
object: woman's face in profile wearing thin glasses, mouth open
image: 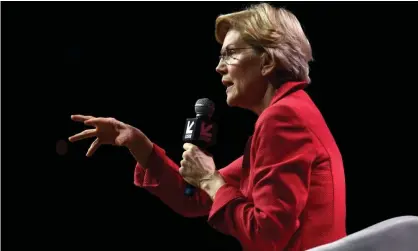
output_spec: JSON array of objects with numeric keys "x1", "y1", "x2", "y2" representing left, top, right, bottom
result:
[{"x1": 216, "y1": 30, "x2": 268, "y2": 110}]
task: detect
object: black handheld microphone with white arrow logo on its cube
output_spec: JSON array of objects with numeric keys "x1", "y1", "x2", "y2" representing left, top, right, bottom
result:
[{"x1": 183, "y1": 98, "x2": 217, "y2": 196}]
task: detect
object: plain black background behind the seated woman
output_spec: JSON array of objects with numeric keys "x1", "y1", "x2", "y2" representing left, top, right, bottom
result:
[{"x1": 1, "y1": 2, "x2": 418, "y2": 250}]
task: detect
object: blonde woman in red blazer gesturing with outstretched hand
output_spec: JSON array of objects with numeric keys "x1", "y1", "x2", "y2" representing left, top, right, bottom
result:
[{"x1": 70, "y1": 4, "x2": 346, "y2": 251}]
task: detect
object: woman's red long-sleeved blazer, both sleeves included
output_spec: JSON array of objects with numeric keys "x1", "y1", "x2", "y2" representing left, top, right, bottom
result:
[{"x1": 135, "y1": 82, "x2": 346, "y2": 251}]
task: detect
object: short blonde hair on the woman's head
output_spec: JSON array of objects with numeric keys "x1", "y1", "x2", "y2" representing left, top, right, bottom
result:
[{"x1": 215, "y1": 3, "x2": 312, "y2": 83}]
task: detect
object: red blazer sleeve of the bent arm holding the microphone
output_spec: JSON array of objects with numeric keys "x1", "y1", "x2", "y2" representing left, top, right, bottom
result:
[{"x1": 208, "y1": 106, "x2": 316, "y2": 250}]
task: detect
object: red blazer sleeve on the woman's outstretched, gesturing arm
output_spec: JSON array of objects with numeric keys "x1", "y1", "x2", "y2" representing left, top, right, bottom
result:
[{"x1": 134, "y1": 144, "x2": 240, "y2": 218}]
